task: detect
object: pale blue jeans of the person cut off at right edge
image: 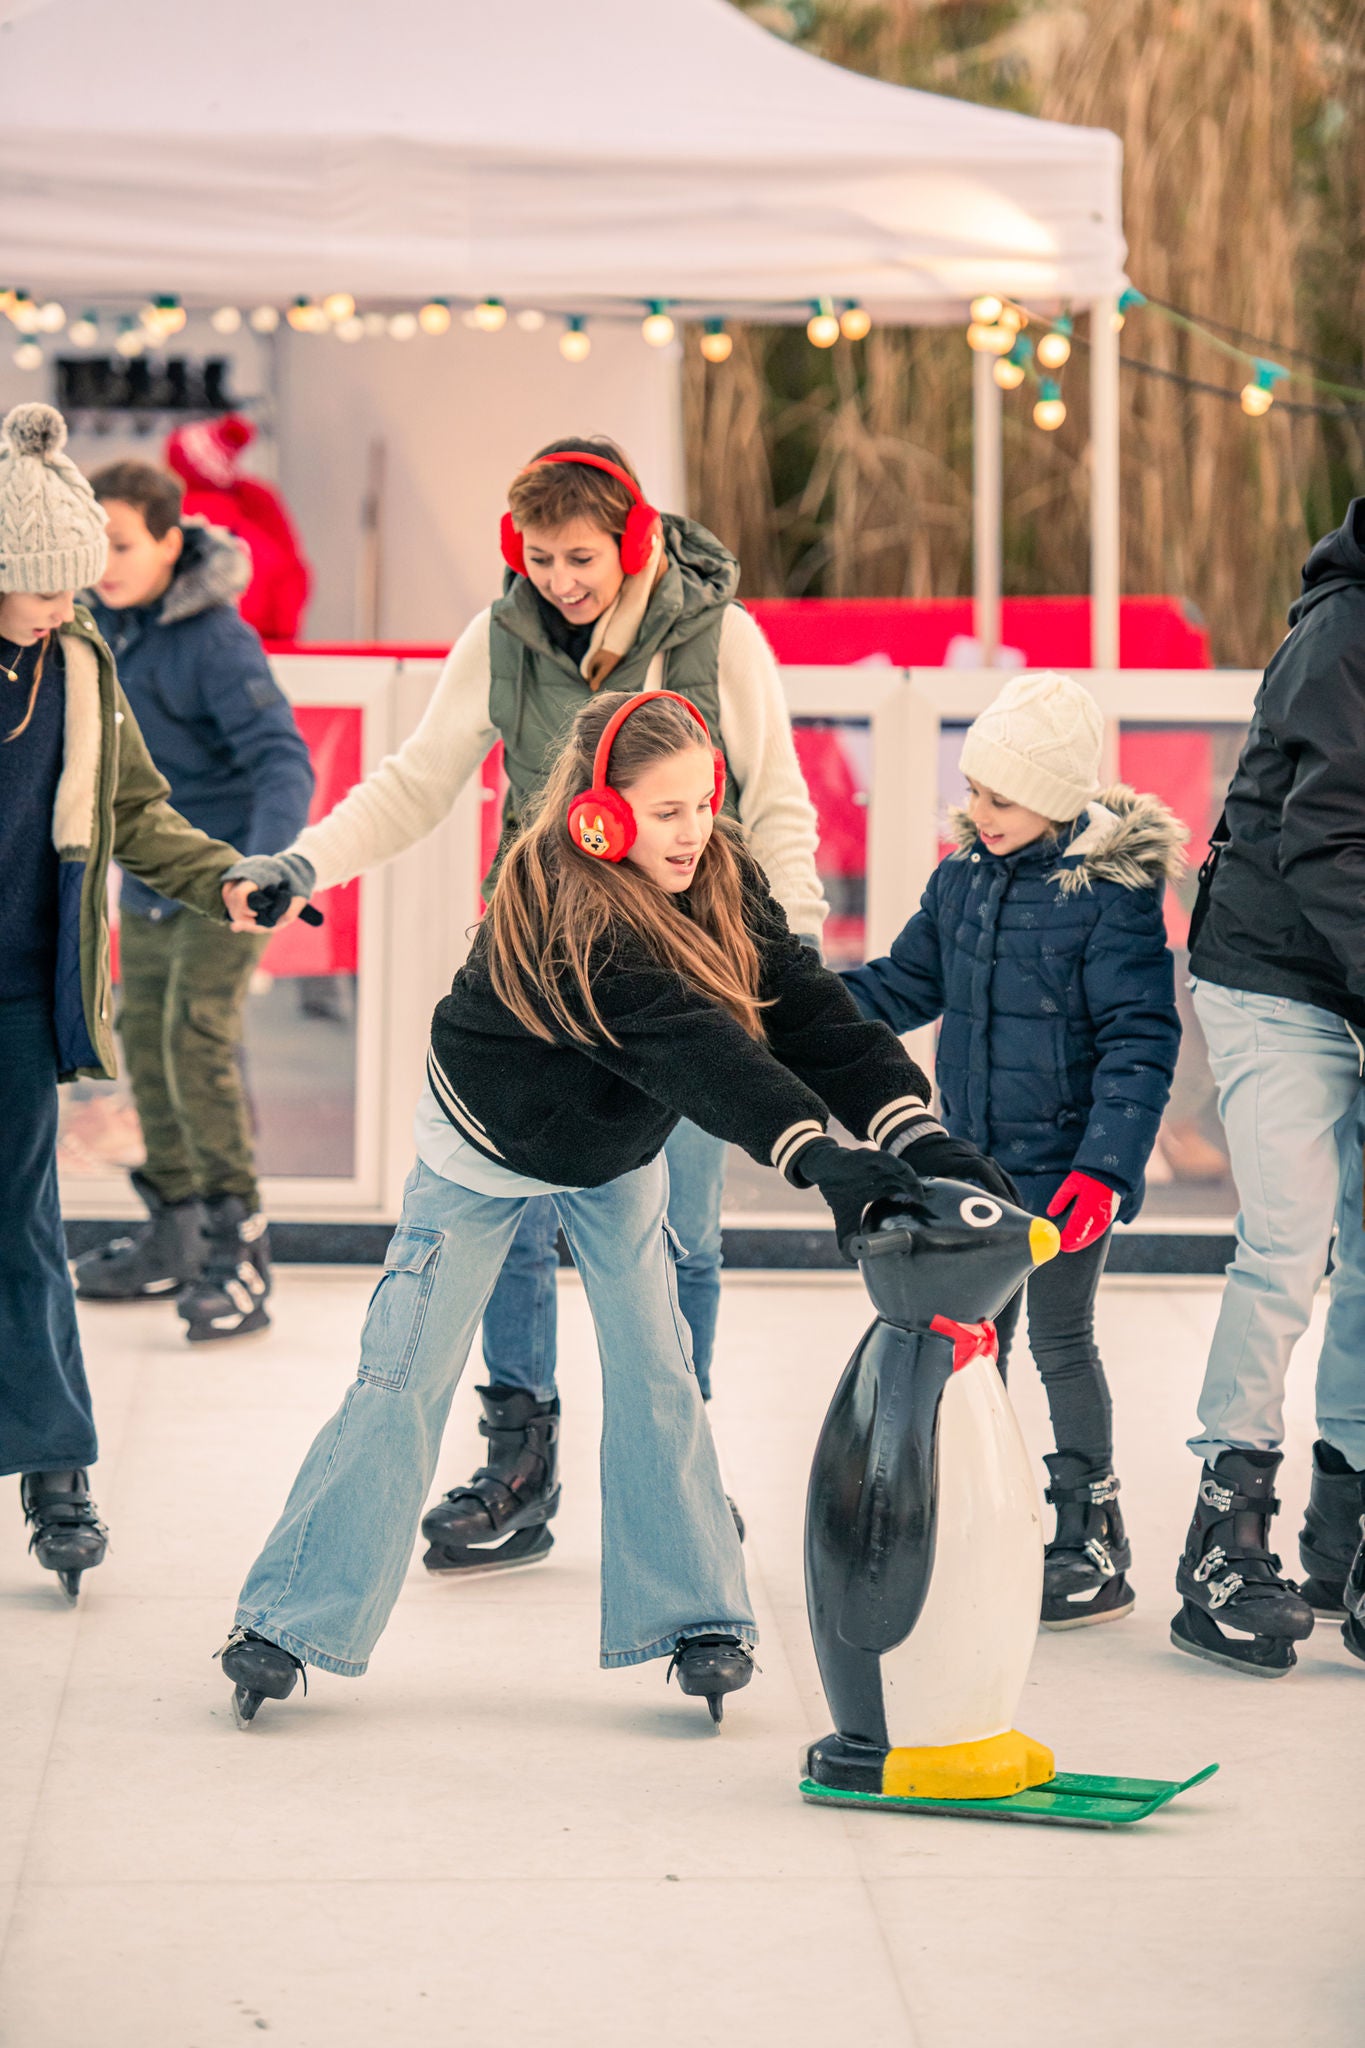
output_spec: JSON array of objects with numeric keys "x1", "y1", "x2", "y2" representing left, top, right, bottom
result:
[{"x1": 1189, "y1": 981, "x2": 1365, "y2": 1468}]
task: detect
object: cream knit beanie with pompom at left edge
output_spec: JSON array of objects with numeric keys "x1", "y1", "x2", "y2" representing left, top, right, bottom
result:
[{"x1": 0, "y1": 406, "x2": 108, "y2": 598}]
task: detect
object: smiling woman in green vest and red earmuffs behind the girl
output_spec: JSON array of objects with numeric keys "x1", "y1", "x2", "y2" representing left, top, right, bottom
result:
[{"x1": 240, "y1": 438, "x2": 827, "y2": 1571}]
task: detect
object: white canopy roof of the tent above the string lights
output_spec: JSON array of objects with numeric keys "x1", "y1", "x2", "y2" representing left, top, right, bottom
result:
[{"x1": 0, "y1": 0, "x2": 1124, "y2": 322}]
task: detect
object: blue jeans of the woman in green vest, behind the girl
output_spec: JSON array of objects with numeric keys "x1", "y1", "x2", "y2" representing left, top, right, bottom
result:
[{"x1": 483, "y1": 1122, "x2": 724, "y2": 1401}]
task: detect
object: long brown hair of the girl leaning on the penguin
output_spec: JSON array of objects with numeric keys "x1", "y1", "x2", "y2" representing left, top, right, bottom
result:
[{"x1": 483, "y1": 692, "x2": 765, "y2": 1044}]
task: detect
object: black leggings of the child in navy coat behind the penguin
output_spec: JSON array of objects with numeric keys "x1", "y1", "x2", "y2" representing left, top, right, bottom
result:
[{"x1": 995, "y1": 1231, "x2": 1113, "y2": 1473}]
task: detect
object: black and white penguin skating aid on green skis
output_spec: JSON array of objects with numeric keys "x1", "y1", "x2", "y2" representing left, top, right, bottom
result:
[{"x1": 800, "y1": 1180, "x2": 1216, "y2": 1827}]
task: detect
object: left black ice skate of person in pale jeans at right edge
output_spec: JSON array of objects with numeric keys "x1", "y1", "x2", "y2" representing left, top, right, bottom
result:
[{"x1": 1171, "y1": 1450, "x2": 1314, "y2": 1677}]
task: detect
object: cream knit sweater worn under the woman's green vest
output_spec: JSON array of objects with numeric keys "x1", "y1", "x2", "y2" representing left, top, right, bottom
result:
[{"x1": 289, "y1": 604, "x2": 829, "y2": 938}]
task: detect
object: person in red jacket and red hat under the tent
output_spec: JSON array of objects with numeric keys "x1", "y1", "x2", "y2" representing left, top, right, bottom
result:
[{"x1": 166, "y1": 412, "x2": 313, "y2": 639}]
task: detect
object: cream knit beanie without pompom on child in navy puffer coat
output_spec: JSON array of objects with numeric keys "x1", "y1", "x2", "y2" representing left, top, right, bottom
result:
[{"x1": 962, "y1": 670, "x2": 1105, "y2": 825}]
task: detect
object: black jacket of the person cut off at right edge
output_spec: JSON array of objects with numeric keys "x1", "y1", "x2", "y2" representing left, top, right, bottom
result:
[{"x1": 1189, "y1": 498, "x2": 1365, "y2": 1024}]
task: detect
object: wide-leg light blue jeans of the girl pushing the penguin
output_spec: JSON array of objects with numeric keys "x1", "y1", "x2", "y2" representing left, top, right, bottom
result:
[{"x1": 237, "y1": 1159, "x2": 757, "y2": 1677}]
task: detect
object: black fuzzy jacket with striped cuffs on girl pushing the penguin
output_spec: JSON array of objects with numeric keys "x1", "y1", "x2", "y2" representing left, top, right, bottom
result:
[{"x1": 428, "y1": 856, "x2": 929, "y2": 1188}]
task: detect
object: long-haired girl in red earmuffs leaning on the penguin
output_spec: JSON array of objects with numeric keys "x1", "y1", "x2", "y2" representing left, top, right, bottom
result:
[{"x1": 221, "y1": 692, "x2": 1009, "y2": 1720}]
